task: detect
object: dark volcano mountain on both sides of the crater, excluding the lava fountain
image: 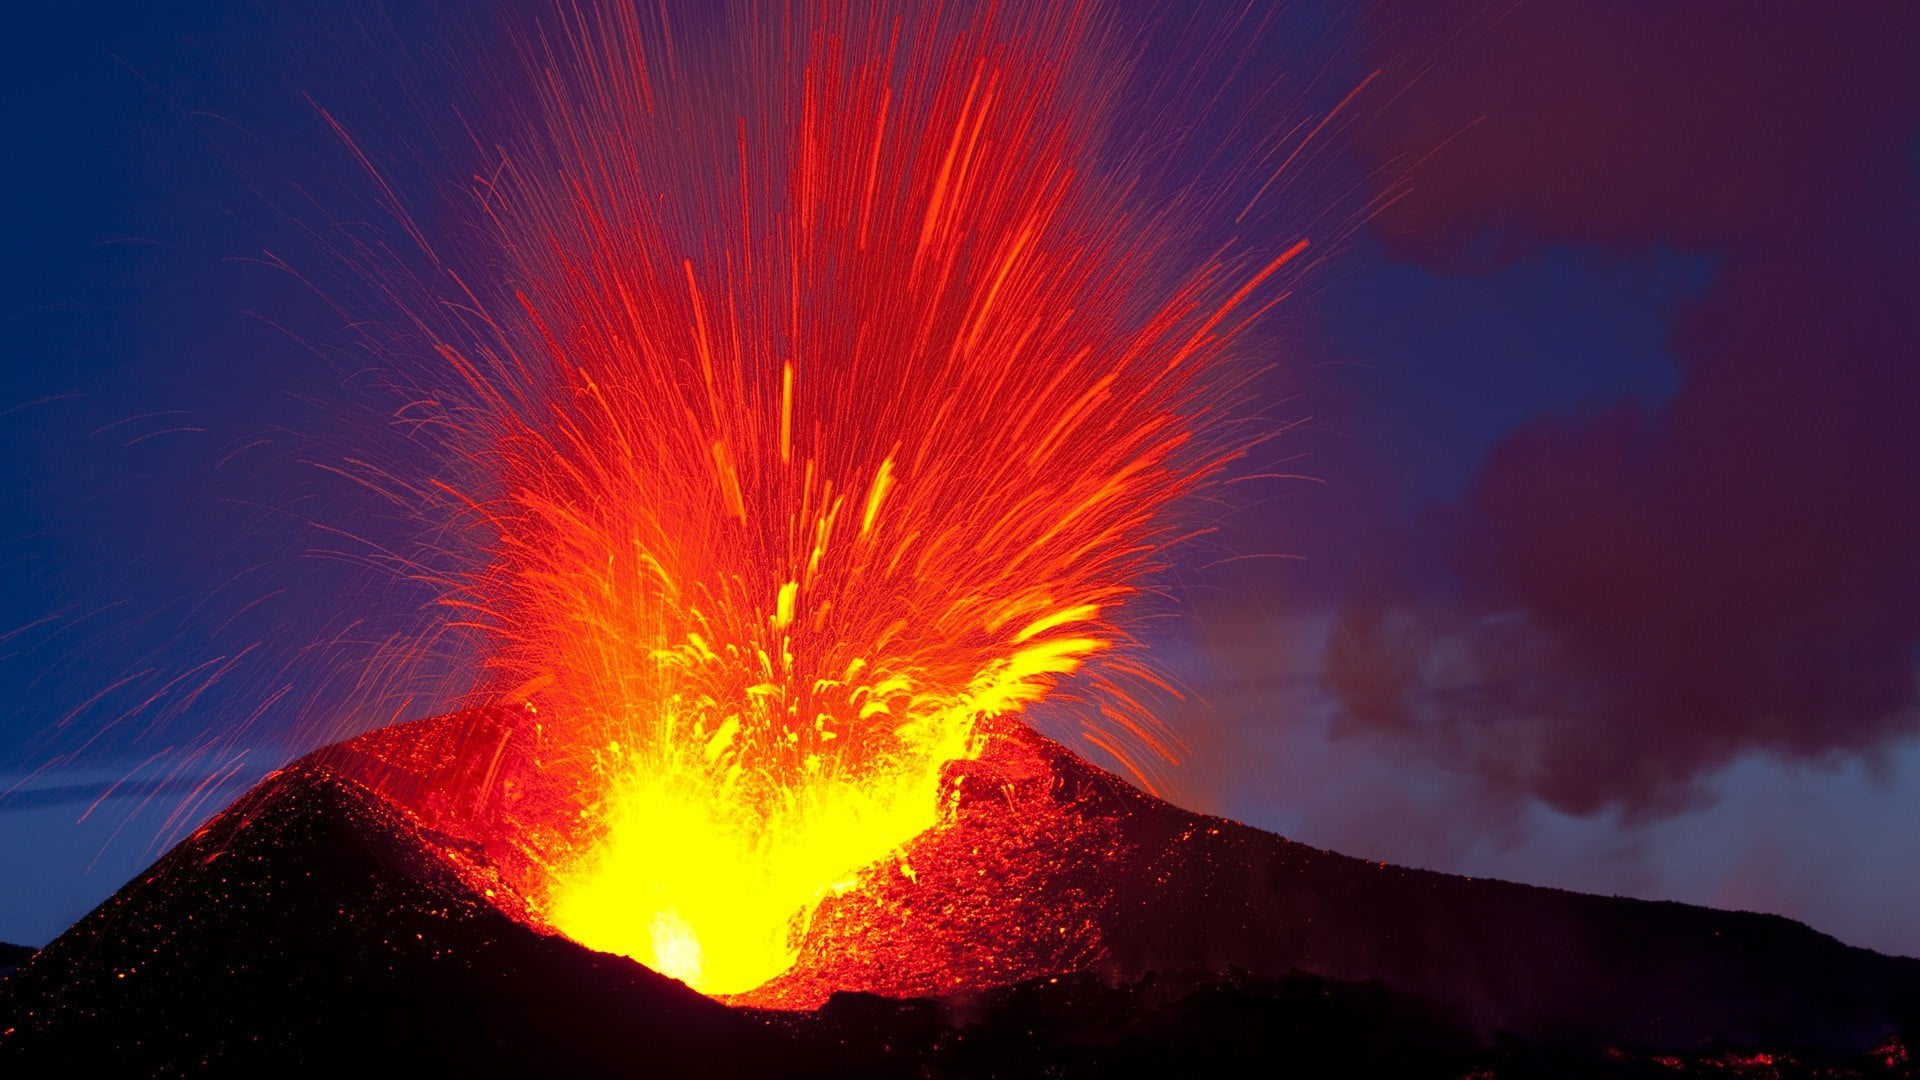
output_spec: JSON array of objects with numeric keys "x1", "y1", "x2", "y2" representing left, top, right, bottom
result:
[{"x1": 0, "y1": 709, "x2": 1920, "y2": 1076}]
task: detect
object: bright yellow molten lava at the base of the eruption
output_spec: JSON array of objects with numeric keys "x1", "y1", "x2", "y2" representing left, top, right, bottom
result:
[{"x1": 547, "y1": 630, "x2": 1104, "y2": 995}]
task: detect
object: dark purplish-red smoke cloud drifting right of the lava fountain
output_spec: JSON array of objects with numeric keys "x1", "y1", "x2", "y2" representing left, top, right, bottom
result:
[{"x1": 1325, "y1": 0, "x2": 1920, "y2": 815}]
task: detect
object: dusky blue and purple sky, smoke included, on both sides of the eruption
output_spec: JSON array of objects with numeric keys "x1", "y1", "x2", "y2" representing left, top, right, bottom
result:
[{"x1": 0, "y1": 0, "x2": 1920, "y2": 955}]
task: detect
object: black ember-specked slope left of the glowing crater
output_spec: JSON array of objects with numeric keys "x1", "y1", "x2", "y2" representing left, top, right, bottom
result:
[{"x1": 0, "y1": 765, "x2": 799, "y2": 1076}]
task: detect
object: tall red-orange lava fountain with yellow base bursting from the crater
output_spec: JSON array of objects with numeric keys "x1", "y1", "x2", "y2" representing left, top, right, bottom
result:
[{"x1": 438, "y1": 4, "x2": 1304, "y2": 994}]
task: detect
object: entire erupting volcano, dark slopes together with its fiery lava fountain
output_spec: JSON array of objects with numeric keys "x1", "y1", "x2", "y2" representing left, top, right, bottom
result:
[{"x1": 0, "y1": 0, "x2": 1920, "y2": 1076}]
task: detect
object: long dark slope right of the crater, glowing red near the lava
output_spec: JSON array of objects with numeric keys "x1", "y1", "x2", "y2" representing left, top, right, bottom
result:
[{"x1": 775, "y1": 726, "x2": 1920, "y2": 1047}]
